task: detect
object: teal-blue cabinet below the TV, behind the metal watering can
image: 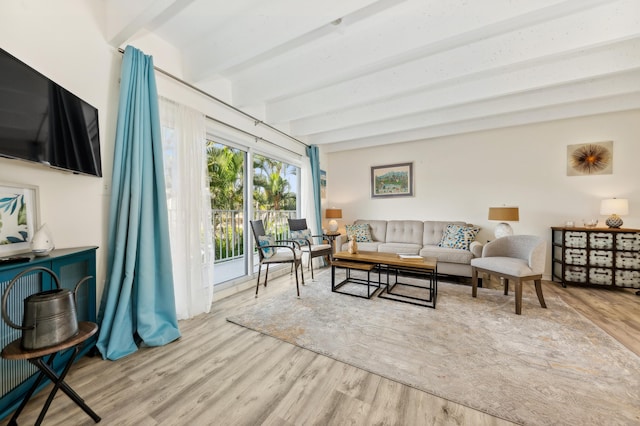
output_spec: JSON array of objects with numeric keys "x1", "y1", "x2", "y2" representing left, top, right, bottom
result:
[{"x1": 0, "y1": 247, "x2": 97, "y2": 419}]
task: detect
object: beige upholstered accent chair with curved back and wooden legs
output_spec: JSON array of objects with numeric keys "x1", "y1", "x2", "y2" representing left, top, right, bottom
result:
[{"x1": 471, "y1": 235, "x2": 547, "y2": 315}]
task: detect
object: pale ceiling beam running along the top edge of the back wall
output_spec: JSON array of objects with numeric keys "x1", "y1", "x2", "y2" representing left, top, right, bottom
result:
[{"x1": 320, "y1": 92, "x2": 640, "y2": 153}]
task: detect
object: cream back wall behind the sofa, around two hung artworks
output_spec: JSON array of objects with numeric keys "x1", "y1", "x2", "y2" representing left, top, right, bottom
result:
[{"x1": 325, "y1": 110, "x2": 640, "y2": 275}]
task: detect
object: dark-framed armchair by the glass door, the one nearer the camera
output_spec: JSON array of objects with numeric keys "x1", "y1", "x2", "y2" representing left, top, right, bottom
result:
[{"x1": 251, "y1": 220, "x2": 304, "y2": 297}]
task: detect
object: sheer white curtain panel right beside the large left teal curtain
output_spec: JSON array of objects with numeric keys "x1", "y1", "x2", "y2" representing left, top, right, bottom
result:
[{"x1": 159, "y1": 98, "x2": 214, "y2": 319}]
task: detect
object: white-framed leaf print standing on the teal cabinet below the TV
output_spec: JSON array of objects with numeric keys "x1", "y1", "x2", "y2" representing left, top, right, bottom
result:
[{"x1": 0, "y1": 183, "x2": 38, "y2": 257}]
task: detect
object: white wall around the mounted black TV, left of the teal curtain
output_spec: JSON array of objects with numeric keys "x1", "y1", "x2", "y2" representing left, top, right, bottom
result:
[{"x1": 0, "y1": 0, "x2": 121, "y2": 298}]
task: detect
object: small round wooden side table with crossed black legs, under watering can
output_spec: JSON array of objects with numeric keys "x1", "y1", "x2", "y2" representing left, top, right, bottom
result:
[{"x1": 2, "y1": 321, "x2": 101, "y2": 425}]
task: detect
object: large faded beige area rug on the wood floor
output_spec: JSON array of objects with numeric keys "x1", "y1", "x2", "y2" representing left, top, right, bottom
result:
[{"x1": 227, "y1": 271, "x2": 640, "y2": 426}]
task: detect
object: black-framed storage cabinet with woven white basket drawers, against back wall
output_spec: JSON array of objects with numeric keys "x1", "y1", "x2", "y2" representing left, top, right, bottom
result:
[{"x1": 551, "y1": 227, "x2": 640, "y2": 288}]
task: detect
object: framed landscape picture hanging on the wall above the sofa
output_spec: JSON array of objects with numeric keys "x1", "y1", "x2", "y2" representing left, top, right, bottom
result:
[{"x1": 371, "y1": 163, "x2": 413, "y2": 198}]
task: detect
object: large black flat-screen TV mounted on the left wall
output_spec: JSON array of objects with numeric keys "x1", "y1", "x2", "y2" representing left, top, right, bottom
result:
[{"x1": 0, "y1": 49, "x2": 102, "y2": 176}]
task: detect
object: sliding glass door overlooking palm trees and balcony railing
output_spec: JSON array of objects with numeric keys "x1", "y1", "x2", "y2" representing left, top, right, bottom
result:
[{"x1": 207, "y1": 140, "x2": 300, "y2": 285}]
